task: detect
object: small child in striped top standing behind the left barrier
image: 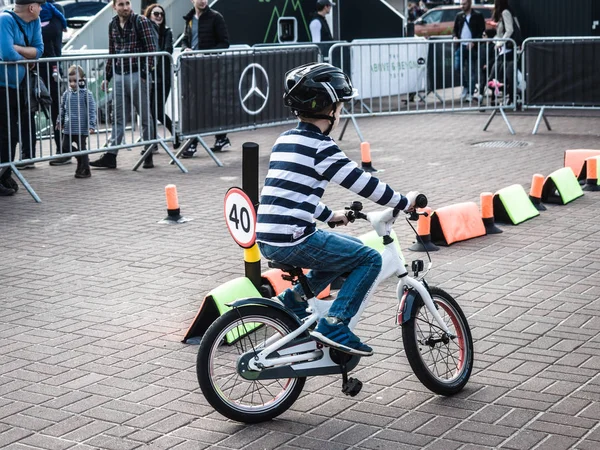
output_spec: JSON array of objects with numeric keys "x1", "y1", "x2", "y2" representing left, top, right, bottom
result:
[{"x1": 56, "y1": 65, "x2": 96, "y2": 178}]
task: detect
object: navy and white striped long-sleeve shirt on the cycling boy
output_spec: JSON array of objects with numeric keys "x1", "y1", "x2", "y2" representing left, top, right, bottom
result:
[{"x1": 256, "y1": 122, "x2": 408, "y2": 246}]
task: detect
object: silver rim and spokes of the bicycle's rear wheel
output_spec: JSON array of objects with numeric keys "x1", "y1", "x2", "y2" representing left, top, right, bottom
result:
[{"x1": 209, "y1": 317, "x2": 297, "y2": 413}]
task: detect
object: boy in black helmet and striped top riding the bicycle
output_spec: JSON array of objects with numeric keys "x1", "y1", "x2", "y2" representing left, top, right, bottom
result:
[{"x1": 256, "y1": 63, "x2": 417, "y2": 356}]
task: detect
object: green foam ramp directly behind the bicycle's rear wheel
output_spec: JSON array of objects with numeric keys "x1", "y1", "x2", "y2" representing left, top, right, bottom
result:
[{"x1": 182, "y1": 277, "x2": 262, "y2": 344}]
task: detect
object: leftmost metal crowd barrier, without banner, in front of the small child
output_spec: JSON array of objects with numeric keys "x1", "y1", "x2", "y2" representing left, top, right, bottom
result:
[{"x1": 0, "y1": 52, "x2": 182, "y2": 202}]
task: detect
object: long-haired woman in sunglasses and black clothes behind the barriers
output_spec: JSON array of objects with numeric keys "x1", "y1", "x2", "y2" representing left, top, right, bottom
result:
[{"x1": 144, "y1": 3, "x2": 179, "y2": 148}]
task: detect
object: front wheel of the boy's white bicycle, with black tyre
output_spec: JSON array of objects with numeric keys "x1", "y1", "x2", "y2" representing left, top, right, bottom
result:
[{"x1": 402, "y1": 288, "x2": 473, "y2": 395}]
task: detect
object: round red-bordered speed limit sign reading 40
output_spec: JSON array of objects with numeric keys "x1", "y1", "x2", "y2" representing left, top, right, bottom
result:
[{"x1": 224, "y1": 188, "x2": 256, "y2": 248}]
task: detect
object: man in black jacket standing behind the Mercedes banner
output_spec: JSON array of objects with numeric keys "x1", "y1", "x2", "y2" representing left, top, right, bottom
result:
[{"x1": 181, "y1": 0, "x2": 231, "y2": 158}]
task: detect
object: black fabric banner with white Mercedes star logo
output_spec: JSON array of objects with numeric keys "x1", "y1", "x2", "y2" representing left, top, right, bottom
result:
[{"x1": 179, "y1": 47, "x2": 319, "y2": 136}]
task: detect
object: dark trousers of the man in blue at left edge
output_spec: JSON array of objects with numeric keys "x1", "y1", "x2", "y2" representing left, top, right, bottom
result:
[{"x1": 0, "y1": 87, "x2": 35, "y2": 179}]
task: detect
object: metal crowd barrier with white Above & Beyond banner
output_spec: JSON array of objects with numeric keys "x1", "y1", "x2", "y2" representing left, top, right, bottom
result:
[{"x1": 329, "y1": 38, "x2": 517, "y2": 139}]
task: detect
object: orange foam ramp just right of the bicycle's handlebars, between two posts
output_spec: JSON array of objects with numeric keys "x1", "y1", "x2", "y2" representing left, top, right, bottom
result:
[{"x1": 431, "y1": 202, "x2": 486, "y2": 245}]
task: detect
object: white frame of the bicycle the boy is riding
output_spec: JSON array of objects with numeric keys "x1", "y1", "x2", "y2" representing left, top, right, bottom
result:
[{"x1": 230, "y1": 209, "x2": 451, "y2": 379}]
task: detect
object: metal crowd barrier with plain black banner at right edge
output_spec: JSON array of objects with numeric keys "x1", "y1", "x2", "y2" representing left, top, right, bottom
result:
[{"x1": 521, "y1": 37, "x2": 600, "y2": 134}]
